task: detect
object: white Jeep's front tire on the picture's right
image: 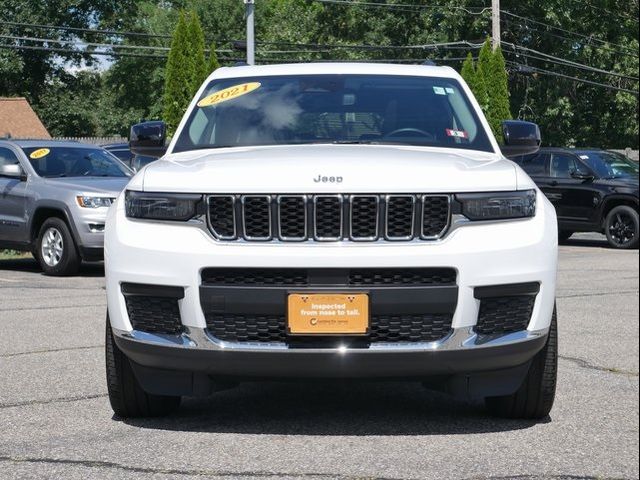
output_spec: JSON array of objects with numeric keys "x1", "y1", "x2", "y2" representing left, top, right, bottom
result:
[{"x1": 485, "y1": 308, "x2": 558, "y2": 419}]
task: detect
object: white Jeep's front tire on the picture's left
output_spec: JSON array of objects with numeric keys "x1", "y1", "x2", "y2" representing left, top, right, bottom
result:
[{"x1": 105, "y1": 315, "x2": 181, "y2": 418}]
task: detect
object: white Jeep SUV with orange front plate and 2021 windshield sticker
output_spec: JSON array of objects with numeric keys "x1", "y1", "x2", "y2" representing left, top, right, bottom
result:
[{"x1": 105, "y1": 63, "x2": 558, "y2": 418}]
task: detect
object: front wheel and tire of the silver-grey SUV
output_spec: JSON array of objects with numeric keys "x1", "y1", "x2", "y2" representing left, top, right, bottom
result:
[{"x1": 34, "y1": 217, "x2": 80, "y2": 276}]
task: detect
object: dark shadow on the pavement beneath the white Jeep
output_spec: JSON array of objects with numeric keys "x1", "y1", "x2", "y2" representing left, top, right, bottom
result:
[{"x1": 121, "y1": 382, "x2": 549, "y2": 436}]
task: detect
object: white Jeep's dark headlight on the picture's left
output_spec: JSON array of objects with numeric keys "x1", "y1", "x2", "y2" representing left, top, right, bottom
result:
[{"x1": 125, "y1": 191, "x2": 202, "y2": 221}]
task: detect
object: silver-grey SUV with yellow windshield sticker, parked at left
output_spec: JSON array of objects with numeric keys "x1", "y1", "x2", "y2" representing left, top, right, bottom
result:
[{"x1": 0, "y1": 140, "x2": 133, "y2": 275}]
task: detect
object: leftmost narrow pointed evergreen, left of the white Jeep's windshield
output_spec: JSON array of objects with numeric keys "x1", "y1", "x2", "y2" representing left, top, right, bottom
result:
[{"x1": 163, "y1": 12, "x2": 193, "y2": 135}]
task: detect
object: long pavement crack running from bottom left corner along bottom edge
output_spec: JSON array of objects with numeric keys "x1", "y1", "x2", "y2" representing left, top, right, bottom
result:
[{"x1": 0, "y1": 455, "x2": 400, "y2": 480}]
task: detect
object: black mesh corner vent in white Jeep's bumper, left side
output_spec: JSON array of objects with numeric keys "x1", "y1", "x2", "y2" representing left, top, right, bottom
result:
[{"x1": 125, "y1": 295, "x2": 182, "y2": 334}]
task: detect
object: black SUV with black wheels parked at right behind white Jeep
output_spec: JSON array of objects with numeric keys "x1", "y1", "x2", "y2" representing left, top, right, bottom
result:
[{"x1": 514, "y1": 148, "x2": 640, "y2": 249}]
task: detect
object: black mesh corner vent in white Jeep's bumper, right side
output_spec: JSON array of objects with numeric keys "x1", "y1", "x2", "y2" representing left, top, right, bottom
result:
[{"x1": 475, "y1": 295, "x2": 536, "y2": 335}]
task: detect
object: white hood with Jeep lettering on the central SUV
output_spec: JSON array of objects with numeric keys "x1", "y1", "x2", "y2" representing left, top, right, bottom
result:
[{"x1": 140, "y1": 145, "x2": 528, "y2": 193}]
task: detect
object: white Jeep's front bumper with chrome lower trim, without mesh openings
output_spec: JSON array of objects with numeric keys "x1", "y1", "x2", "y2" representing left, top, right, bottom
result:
[{"x1": 105, "y1": 188, "x2": 557, "y2": 386}]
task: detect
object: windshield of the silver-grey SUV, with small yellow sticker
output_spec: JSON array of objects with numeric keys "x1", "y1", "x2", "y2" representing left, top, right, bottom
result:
[{"x1": 23, "y1": 147, "x2": 131, "y2": 178}]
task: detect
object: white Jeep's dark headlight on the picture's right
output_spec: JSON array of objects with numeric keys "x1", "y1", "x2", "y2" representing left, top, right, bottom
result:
[{"x1": 456, "y1": 190, "x2": 536, "y2": 220}]
